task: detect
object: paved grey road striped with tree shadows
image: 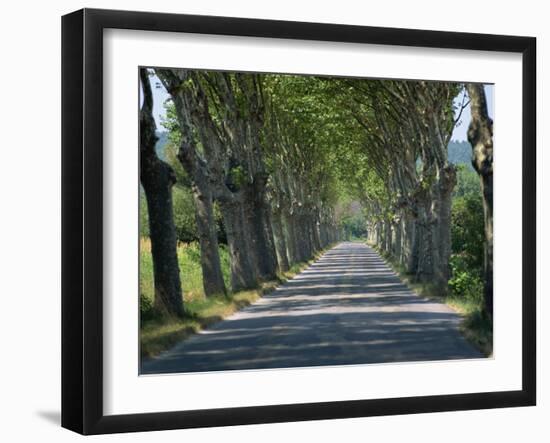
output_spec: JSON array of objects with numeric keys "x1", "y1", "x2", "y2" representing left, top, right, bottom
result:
[{"x1": 141, "y1": 242, "x2": 483, "y2": 374}]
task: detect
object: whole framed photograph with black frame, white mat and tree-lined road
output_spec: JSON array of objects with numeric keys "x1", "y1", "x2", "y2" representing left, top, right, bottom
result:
[{"x1": 62, "y1": 9, "x2": 536, "y2": 434}]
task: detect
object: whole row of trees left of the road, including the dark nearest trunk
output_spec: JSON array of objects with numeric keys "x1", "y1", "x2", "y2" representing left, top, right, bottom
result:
[{"x1": 140, "y1": 69, "x2": 340, "y2": 315}]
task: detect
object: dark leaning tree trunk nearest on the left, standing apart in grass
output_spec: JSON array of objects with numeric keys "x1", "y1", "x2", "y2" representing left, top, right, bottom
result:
[{"x1": 139, "y1": 68, "x2": 184, "y2": 317}]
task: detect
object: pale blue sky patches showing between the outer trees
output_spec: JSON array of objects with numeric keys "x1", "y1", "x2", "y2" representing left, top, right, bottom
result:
[{"x1": 143, "y1": 76, "x2": 495, "y2": 141}]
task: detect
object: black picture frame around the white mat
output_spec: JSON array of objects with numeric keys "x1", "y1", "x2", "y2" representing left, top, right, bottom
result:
[{"x1": 62, "y1": 9, "x2": 536, "y2": 434}]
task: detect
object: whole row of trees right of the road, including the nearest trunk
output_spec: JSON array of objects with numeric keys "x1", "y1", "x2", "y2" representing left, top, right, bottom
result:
[{"x1": 346, "y1": 80, "x2": 493, "y2": 317}]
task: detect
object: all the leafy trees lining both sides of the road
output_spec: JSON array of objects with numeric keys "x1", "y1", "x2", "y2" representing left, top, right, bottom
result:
[{"x1": 140, "y1": 69, "x2": 492, "y2": 315}]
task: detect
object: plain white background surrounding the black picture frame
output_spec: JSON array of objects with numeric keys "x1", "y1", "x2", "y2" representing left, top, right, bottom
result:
[{"x1": 0, "y1": 0, "x2": 550, "y2": 443}]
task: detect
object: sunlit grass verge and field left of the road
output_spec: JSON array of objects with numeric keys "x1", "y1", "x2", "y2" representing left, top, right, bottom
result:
[{"x1": 139, "y1": 238, "x2": 328, "y2": 357}]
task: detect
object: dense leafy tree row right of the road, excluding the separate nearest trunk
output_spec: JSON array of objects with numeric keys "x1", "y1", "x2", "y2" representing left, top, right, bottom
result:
[{"x1": 344, "y1": 81, "x2": 458, "y2": 293}]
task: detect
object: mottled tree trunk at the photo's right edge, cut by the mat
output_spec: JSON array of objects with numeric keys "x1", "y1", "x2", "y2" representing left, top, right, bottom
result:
[{"x1": 466, "y1": 84, "x2": 493, "y2": 318}]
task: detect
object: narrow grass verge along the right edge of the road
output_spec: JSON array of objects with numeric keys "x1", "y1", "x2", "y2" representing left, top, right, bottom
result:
[{"x1": 369, "y1": 244, "x2": 493, "y2": 357}]
